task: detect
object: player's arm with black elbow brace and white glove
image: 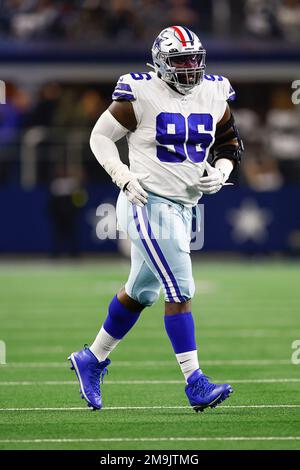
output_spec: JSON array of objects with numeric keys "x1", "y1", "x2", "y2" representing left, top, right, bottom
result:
[{"x1": 200, "y1": 104, "x2": 244, "y2": 194}]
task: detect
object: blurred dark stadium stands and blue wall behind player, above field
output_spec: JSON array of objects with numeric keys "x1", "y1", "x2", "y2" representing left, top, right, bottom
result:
[{"x1": 0, "y1": 0, "x2": 300, "y2": 256}]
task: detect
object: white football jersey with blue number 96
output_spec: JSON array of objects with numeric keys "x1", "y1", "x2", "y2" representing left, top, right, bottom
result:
[{"x1": 113, "y1": 72, "x2": 235, "y2": 207}]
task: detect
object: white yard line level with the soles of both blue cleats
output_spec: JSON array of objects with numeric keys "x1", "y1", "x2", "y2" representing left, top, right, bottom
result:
[{"x1": 0, "y1": 404, "x2": 300, "y2": 412}]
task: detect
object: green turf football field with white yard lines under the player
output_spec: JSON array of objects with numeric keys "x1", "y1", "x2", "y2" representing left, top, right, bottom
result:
[{"x1": 0, "y1": 259, "x2": 300, "y2": 450}]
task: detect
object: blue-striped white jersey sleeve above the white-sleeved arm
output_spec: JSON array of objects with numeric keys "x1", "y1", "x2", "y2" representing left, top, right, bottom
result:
[{"x1": 112, "y1": 74, "x2": 142, "y2": 124}]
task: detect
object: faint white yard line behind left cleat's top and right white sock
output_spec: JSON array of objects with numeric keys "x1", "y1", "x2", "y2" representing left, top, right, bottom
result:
[{"x1": 0, "y1": 359, "x2": 291, "y2": 369}]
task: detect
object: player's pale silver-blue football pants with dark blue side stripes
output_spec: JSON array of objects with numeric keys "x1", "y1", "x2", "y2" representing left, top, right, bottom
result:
[{"x1": 117, "y1": 191, "x2": 195, "y2": 306}]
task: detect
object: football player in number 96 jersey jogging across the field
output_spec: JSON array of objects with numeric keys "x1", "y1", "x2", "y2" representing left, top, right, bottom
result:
[{"x1": 69, "y1": 26, "x2": 243, "y2": 411}]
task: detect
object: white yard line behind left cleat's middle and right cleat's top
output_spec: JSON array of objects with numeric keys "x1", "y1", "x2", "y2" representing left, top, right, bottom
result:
[{"x1": 0, "y1": 378, "x2": 300, "y2": 387}]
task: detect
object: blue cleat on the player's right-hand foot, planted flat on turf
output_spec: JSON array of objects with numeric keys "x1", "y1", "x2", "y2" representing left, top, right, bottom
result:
[{"x1": 185, "y1": 369, "x2": 233, "y2": 413}]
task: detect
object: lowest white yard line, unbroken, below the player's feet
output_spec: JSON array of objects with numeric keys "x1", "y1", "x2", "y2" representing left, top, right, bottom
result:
[{"x1": 0, "y1": 436, "x2": 300, "y2": 444}]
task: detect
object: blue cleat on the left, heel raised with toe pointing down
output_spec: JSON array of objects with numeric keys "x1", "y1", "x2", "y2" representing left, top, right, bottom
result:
[{"x1": 68, "y1": 347, "x2": 110, "y2": 410}]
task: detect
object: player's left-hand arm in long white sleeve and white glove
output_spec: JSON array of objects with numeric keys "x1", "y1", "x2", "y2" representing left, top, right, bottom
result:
[{"x1": 90, "y1": 101, "x2": 147, "y2": 206}]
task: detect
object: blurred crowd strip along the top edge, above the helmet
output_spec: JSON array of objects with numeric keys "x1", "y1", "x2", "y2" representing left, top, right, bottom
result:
[{"x1": 0, "y1": 0, "x2": 300, "y2": 43}]
